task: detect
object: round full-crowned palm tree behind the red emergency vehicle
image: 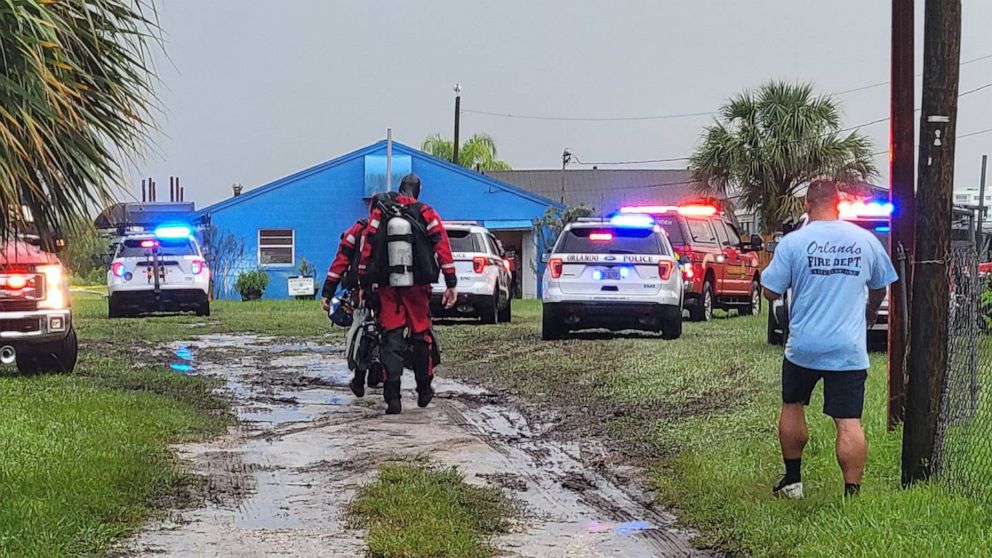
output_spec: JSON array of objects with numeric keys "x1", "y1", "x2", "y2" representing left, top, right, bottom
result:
[{"x1": 689, "y1": 81, "x2": 877, "y2": 232}]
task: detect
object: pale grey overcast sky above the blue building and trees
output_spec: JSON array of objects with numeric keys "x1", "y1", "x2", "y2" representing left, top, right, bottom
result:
[{"x1": 129, "y1": 0, "x2": 992, "y2": 207}]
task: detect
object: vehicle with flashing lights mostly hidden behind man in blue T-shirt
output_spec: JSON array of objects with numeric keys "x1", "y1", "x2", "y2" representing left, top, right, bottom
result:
[{"x1": 767, "y1": 200, "x2": 893, "y2": 346}]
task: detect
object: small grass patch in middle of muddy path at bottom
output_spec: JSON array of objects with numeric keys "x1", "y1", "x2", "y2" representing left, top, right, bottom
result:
[{"x1": 351, "y1": 463, "x2": 511, "y2": 558}]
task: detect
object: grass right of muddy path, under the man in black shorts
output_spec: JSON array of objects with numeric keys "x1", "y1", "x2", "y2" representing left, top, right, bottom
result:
[{"x1": 440, "y1": 303, "x2": 992, "y2": 557}]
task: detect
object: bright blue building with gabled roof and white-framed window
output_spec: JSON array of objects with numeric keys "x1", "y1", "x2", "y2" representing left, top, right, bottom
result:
[{"x1": 198, "y1": 141, "x2": 559, "y2": 298}]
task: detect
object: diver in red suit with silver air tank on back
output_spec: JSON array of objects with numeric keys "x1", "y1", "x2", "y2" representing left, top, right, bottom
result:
[{"x1": 358, "y1": 173, "x2": 458, "y2": 415}]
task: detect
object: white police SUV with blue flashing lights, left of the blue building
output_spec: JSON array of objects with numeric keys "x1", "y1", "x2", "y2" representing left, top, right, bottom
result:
[{"x1": 107, "y1": 225, "x2": 210, "y2": 318}]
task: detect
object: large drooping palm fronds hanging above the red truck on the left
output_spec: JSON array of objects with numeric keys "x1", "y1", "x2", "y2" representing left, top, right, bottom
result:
[{"x1": 0, "y1": 0, "x2": 158, "y2": 245}]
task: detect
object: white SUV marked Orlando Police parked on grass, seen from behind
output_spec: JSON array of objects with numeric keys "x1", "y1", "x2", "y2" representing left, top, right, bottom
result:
[{"x1": 541, "y1": 214, "x2": 683, "y2": 340}]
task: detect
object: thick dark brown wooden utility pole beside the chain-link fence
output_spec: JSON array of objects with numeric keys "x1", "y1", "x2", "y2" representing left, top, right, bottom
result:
[{"x1": 902, "y1": 0, "x2": 961, "y2": 486}]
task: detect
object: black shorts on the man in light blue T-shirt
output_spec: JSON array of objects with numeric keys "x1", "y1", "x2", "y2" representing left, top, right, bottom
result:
[{"x1": 782, "y1": 359, "x2": 868, "y2": 419}]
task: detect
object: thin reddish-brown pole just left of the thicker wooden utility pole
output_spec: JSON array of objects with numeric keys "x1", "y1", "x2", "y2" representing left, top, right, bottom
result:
[{"x1": 888, "y1": 0, "x2": 916, "y2": 430}]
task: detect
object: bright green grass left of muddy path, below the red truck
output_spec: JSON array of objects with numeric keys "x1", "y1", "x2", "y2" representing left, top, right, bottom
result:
[{"x1": 0, "y1": 294, "x2": 230, "y2": 556}]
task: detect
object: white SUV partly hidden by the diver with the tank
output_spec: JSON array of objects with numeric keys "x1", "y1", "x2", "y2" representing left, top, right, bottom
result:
[{"x1": 431, "y1": 222, "x2": 513, "y2": 324}]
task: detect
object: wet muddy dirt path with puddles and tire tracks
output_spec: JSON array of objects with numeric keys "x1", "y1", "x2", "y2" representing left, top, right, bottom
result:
[{"x1": 126, "y1": 336, "x2": 702, "y2": 558}]
